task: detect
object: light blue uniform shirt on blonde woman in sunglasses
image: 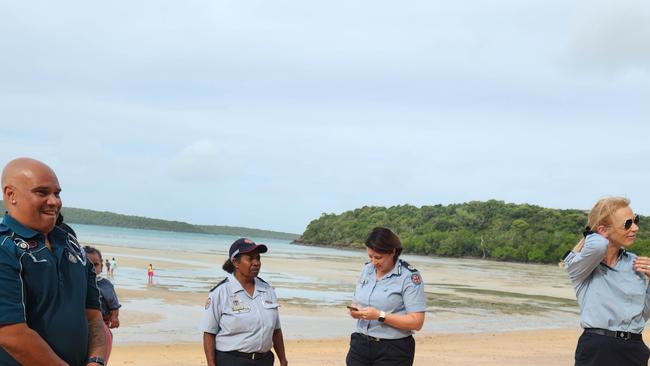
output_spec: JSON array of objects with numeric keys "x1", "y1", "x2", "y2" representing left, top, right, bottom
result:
[{"x1": 564, "y1": 234, "x2": 650, "y2": 333}]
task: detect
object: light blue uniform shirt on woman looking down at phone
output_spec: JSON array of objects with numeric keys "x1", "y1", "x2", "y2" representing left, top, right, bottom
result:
[{"x1": 352, "y1": 259, "x2": 427, "y2": 339}]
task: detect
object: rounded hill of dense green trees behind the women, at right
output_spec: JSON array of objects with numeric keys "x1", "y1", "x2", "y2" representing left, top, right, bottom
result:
[{"x1": 297, "y1": 200, "x2": 650, "y2": 263}]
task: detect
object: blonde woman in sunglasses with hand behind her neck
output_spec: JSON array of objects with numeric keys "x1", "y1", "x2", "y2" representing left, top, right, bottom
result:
[{"x1": 564, "y1": 197, "x2": 650, "y2": 366}]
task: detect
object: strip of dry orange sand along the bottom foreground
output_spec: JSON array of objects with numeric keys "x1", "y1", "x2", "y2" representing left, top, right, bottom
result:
[{"x1": 110, "y1": 329, "x2": 579, "y2": 366}]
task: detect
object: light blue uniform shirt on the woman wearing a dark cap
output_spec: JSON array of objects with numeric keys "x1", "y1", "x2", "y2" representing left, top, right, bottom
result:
[{"x1": 200, "y1": 274, "x2": 280, "y2": 353}]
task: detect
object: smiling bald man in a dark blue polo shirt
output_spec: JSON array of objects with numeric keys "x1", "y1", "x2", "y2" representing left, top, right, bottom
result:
[{"x1": 0, "y1": 158, "x2": 105, "y2": 366}]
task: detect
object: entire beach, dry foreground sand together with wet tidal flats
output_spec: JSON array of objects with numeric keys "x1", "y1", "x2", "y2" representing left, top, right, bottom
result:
[{"x1": 82, "y1": 237, "x2": 580, "y2": 366}]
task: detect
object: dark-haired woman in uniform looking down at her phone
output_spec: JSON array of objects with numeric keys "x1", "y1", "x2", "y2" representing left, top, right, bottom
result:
[{"x1": 346, "y1": 227, "x2": 427, "y2": 366}]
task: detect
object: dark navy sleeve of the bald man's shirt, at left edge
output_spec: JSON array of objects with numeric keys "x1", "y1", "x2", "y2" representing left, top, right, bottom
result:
[{"x1": 0, "y1": 242, "x2": 26, "y2": 325}]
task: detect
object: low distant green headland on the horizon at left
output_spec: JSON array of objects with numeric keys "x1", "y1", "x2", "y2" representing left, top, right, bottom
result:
[{"x1": 0, "y1": 201, "x2": 298, "y2": 240}]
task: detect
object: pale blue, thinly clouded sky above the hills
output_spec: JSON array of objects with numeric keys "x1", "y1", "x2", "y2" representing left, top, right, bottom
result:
[{"x1": 0, "y1": 0, "x2": 650, "y2": 233}]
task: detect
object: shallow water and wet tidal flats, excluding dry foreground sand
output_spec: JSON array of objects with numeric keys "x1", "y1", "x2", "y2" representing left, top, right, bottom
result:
[{"x1": 74, "y1": 225, "x2": 578, "y2": 343}]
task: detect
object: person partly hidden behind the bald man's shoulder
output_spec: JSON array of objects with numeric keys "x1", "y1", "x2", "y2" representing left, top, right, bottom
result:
[{"x1": 84, "y1": 245, "x2": 122, "y2": 364}]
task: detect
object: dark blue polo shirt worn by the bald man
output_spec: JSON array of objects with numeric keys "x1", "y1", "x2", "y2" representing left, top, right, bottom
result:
[{"x1": 0, "y1": 214, "x2": 99, "y2": 366}]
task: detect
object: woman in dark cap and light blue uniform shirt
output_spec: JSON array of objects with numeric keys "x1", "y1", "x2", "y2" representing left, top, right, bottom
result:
[{"x1": 200, "y1": 238, "x2": 287, "y2": 366}]
